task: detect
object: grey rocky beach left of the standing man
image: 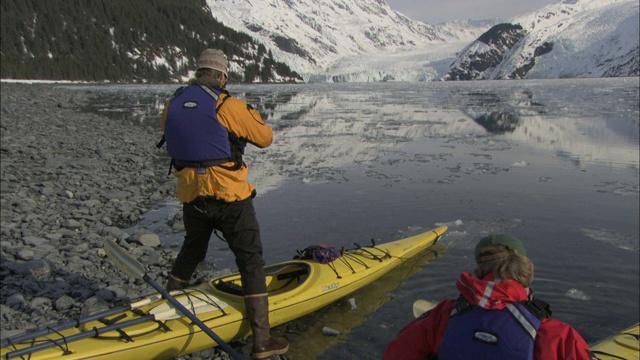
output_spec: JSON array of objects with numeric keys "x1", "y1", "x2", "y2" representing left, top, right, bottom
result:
[{"x1": 0, "y1": 82, "x2": 252, "y2": 359}]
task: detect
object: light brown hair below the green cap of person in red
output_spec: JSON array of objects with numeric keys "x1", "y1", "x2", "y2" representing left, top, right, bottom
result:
[{"x1": 475, "y1": 244, "x2": 533, "y2": 287}]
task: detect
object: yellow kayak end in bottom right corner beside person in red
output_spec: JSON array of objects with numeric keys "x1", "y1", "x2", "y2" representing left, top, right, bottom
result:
[{"x1": 590, "y1": 323, "x2": 640, "y2": 360}]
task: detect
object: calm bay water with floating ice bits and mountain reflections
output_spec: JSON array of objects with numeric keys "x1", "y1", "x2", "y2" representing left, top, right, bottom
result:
[{"x1": 67, "y1": 78, "x2": 640, "y2": 359}]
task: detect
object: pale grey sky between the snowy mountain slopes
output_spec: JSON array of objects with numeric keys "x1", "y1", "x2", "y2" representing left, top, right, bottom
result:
[{"x1": 385, "y1": 0, "x2": 559, "y2": 24}]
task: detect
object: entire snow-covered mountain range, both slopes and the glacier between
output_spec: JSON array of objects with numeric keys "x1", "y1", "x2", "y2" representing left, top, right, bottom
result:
[{"x1": 207, "y1": 0, "x2": 640, "y2": 82}]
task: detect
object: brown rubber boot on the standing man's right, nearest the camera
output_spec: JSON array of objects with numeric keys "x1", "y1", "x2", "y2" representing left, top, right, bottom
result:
[{"x1": 244, "y1": 294, "x2": 289, "y2": 359}]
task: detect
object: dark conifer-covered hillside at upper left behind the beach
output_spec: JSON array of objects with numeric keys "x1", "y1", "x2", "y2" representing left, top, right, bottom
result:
[{"x1": 0, "y1": 0, "x2": 300, "y2": 82}]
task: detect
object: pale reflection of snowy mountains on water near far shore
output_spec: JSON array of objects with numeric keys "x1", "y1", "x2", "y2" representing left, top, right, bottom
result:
[{"x1": 77, "y1": 79, "x2": 638, "y2": 173}]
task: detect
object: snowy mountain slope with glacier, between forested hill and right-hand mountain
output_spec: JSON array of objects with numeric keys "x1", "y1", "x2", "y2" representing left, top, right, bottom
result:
[{"x1": 207, "y1": 0, "x2": 496, "y2": 82}]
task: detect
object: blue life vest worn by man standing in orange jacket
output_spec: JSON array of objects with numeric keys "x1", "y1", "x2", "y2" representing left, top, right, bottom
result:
[{"x1": 164, "y1": 85, "x2": 231, "y2": 163}]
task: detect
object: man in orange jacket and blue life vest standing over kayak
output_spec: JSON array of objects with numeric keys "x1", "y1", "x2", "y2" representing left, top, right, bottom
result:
[{"x1": 160, "y1": 49, "x2": 289, "y2": 359}]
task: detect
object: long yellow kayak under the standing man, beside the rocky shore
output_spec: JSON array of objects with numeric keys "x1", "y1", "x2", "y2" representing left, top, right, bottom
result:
[{"x1": 0, "y1": 226, "x2": 447, "y2": 360}]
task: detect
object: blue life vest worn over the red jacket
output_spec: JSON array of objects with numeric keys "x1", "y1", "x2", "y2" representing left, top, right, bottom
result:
[{"x1": 438, "y1": 299, "x2": 542, "y2": 360}]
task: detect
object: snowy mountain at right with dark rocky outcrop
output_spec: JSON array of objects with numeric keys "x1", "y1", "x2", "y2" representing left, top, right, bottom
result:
[{"x1": 443, "y1": 0, "x2": 640, "y2": 80}]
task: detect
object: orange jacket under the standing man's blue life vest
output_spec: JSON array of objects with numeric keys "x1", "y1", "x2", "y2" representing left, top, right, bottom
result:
[{"x1": 160, "y1": 88, "x2": 273, "y2": 203}]
